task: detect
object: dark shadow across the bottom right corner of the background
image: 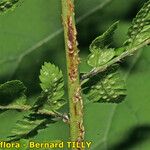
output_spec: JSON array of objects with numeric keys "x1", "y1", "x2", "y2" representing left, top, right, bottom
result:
[{"x1": 109, "y1": 125, "x2": 150, "y2": 150}]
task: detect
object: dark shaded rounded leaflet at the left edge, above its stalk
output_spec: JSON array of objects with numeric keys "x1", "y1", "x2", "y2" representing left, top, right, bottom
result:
[{"x1": 0, "y1": 80, "x2": 26, "y2": 106}]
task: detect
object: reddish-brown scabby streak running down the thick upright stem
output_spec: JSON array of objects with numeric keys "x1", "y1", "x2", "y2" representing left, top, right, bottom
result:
[{"x1": 66, "y1": 0, "x2": 84, "y2": 142}]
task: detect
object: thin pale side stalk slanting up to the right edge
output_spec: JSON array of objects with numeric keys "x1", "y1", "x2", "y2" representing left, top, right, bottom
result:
[{"x1": 81, "y1": 39, "x2": 150, "y2": 83}]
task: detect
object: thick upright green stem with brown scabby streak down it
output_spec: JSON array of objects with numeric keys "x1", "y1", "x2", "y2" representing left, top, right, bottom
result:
[{"x1": 62, "y1": 0, "x2": 84, "y2": 142}]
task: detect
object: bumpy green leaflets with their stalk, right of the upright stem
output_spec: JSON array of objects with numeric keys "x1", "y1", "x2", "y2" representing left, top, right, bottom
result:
[{"x1": 82, "y1": 1, "x2": 150, "y2": 102}]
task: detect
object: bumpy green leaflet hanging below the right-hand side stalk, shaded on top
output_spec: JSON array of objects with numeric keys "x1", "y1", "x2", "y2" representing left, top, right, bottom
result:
[{"x1": 83, "y1": 69, "x2": 126, "y2": 103}]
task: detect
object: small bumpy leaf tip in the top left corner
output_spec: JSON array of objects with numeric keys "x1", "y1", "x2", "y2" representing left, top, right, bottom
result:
[{"x1": 0, "y1": 0, "x2": 19, "y2": 14}]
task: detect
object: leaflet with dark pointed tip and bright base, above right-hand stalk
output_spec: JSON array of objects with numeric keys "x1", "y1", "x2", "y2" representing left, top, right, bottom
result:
[{"x1": 87, "y1": 22, "x2": 118, "y2": 68}]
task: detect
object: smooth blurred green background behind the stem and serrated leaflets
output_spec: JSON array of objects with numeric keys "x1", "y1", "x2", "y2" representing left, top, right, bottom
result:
[{"x1": 0, "y1": 0, "x2": 150, "y2": 150}]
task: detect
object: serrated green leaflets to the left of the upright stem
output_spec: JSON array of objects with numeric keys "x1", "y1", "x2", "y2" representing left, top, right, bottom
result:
[{"x1": 0, "y1": 63, "x2": 65, "y2": 140}]
